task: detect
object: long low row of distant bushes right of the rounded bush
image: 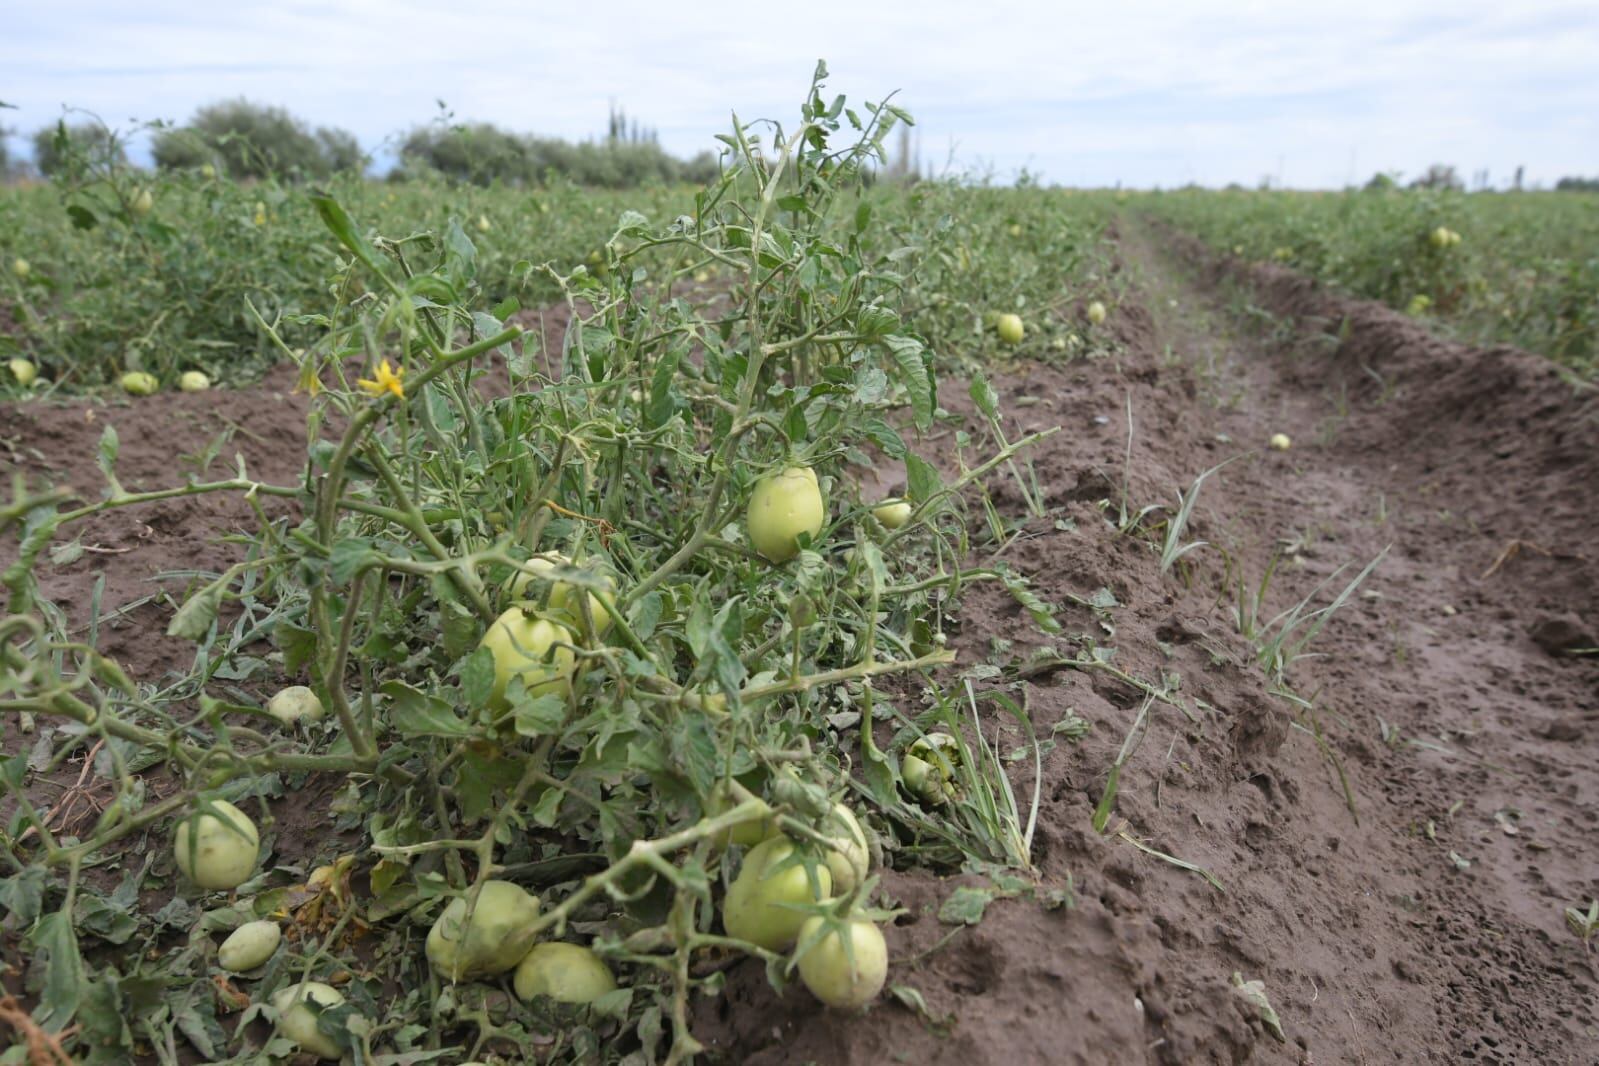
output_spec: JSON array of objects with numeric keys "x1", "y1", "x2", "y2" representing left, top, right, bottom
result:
[{"x1": 390, "y1": 123, "x2": 716, "y2": 189}]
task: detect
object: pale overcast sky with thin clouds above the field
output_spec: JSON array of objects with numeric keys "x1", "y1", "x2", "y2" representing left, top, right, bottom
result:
[{"x1": 0, "y1": 0, "x2": 1599, "y2": 187}]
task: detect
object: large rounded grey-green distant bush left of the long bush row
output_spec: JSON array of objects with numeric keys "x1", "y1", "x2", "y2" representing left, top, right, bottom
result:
[{"x1": 152, "y1": 99, "x2": 366, "y2": 177}]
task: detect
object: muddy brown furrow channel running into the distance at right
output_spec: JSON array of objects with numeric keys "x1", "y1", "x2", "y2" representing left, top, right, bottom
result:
[{"x1": 1122, "y1": 225, "x2": 1599, "y2": 1063}]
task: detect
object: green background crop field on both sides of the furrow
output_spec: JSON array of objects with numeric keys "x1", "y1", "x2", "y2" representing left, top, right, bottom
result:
[{"x1": 0, "y1": 168, "x2": 1599, "y2": 390}]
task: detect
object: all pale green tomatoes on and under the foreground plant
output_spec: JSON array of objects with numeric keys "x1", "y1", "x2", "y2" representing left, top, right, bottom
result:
[{"x1": 157, "y1": 467, "x2": 959, "y2": 1060}]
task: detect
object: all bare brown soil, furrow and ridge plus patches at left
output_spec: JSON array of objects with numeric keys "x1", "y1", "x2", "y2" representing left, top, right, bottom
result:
[{"x1": 0, "y1": 222, "x2": 1599, "y2": 1066}]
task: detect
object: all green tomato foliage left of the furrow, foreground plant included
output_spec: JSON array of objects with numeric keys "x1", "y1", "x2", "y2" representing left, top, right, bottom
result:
[{"x1": 0, "y1": 70, "x2": 1111, "y2": 1064}]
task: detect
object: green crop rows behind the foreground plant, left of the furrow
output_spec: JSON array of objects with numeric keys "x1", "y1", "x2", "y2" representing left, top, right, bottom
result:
[{"x1": 0, "y1": 168, "x2": 1113, "y2": 392}]
